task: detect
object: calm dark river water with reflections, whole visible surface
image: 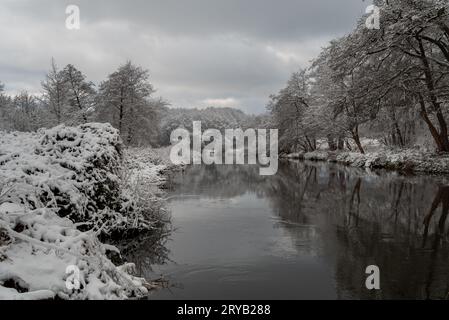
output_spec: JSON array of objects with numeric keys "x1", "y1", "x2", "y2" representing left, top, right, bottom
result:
[{"x1": 139, "y1": 161, "x2": 449, "y2": 299}]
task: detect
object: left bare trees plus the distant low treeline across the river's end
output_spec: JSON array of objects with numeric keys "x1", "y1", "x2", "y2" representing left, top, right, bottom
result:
[{"x1": 0, "y1": 60, "x2": 269, "y2": 146}]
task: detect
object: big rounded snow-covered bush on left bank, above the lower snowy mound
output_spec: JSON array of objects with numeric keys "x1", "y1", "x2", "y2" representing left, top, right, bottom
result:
[{"x1": 0, "y1": 123, "x2": 163, "y2": 236}]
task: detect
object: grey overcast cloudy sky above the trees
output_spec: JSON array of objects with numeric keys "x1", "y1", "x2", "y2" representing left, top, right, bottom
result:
[{"x1": 0, "y1": 0, "x2": 371, "y2": 113}]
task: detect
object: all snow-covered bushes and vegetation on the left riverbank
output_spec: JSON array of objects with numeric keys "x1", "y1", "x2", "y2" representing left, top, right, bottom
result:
[{"x1": 0, "y1": 123, "x2": 172, "y2": 299}]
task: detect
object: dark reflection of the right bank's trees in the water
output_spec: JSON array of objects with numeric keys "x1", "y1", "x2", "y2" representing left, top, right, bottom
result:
[{"x1": 272, "y1": 163, "x2": 449, "y2": 299}]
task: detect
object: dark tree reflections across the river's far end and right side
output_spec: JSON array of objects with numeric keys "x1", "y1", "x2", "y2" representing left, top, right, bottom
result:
[{"x1": 136, "y1": 161, "x2": 449, "y2": 299}]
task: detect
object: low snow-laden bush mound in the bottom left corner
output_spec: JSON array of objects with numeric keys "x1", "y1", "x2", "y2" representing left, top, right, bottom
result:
[{"x1": 0, "y1": 203, "x2": 150, "y2": 299}]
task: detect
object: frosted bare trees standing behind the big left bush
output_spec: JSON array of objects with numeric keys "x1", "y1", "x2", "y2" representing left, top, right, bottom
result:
[{"x1": 0, "y1": 60, "x2": 166, "y2": 144}]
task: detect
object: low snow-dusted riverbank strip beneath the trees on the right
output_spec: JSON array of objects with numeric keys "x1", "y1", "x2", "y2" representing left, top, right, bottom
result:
[{"x1": 280, "y1": 149, "x2": 449, "y2": 174}]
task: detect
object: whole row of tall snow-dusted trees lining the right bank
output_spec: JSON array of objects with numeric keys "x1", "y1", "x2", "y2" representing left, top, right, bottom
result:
[{"x1": 268, "y1": 0, "x2": 449, "y2": 153}]
